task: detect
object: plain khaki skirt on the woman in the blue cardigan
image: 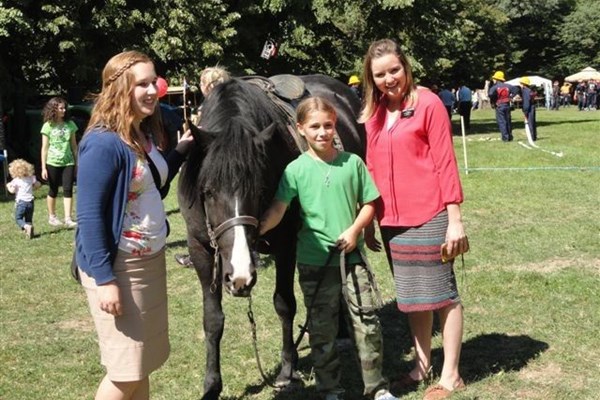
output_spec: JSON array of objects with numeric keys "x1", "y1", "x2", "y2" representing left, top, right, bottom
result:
[{"x1": 79, "y1": 248, "x2": 170, "y2": 382}]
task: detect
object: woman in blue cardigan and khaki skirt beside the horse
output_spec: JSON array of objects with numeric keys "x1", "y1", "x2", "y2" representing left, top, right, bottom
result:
[{"x1": 75, "y1": 51, "x2": 193, "y2": 400}]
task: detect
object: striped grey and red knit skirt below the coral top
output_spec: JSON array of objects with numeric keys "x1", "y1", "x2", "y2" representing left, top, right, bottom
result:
[{"x1": 381, "y1": 210, "x2": 460, "y2": 313}]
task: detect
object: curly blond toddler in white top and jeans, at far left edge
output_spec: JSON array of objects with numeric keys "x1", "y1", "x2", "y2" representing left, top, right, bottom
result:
[{"x1": 6, "y1": 158, "x2": 41, "y2": 239}]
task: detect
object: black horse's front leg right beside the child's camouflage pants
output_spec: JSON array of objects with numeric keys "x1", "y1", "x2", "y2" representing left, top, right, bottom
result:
[{"x1": 273, "y1": 237, "x2": 301, "y2": 386}]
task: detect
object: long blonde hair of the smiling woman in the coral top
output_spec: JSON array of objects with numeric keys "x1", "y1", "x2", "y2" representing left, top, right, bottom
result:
[{"x1": 358, "y1": 39, "x2": 417, "y2": 123}]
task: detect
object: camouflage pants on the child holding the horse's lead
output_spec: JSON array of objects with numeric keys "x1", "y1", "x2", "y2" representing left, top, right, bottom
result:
[{"x1": 298, "y1": 264, "x2": 387, "y2": 395}]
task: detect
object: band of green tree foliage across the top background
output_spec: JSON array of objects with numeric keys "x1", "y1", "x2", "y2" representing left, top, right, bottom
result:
[{"x1": 0, "y1": 0, "x2": 600, "y2": 104}]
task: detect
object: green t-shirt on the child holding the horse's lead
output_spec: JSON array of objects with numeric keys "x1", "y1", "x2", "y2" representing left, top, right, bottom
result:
[{"x1": 275, "y1": 152, "x2": 379, "y2": 266}]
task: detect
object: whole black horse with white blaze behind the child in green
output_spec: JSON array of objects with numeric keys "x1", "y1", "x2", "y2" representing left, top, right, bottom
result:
[{"x1": 178, "y1": 75, "x2": 364, "y2": 399}]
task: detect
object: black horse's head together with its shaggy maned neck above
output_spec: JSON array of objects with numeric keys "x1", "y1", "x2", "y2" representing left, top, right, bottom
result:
[{"x1": 183, "y1": 79, "x2": 290, "y2": 296}]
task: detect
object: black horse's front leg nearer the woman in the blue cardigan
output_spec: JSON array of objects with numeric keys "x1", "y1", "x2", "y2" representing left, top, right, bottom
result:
[{"x1": 189, "y1": 239, "x2": 225, "y2": 400}]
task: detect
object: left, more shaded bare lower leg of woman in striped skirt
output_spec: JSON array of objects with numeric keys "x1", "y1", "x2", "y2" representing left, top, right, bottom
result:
[{"x1": 408, "y1": 311, "x2": 433, "y2": 381}]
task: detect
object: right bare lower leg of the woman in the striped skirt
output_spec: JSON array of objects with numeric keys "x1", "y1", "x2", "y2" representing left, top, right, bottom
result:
[{"x1": 439, "y1": 303, "x2": 463, "y2": 390}]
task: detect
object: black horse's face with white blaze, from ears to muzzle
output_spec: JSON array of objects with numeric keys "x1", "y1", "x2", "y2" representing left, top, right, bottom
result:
[{"x1": 192, "y1": 118, "x2": 276, "y2": 296}]
